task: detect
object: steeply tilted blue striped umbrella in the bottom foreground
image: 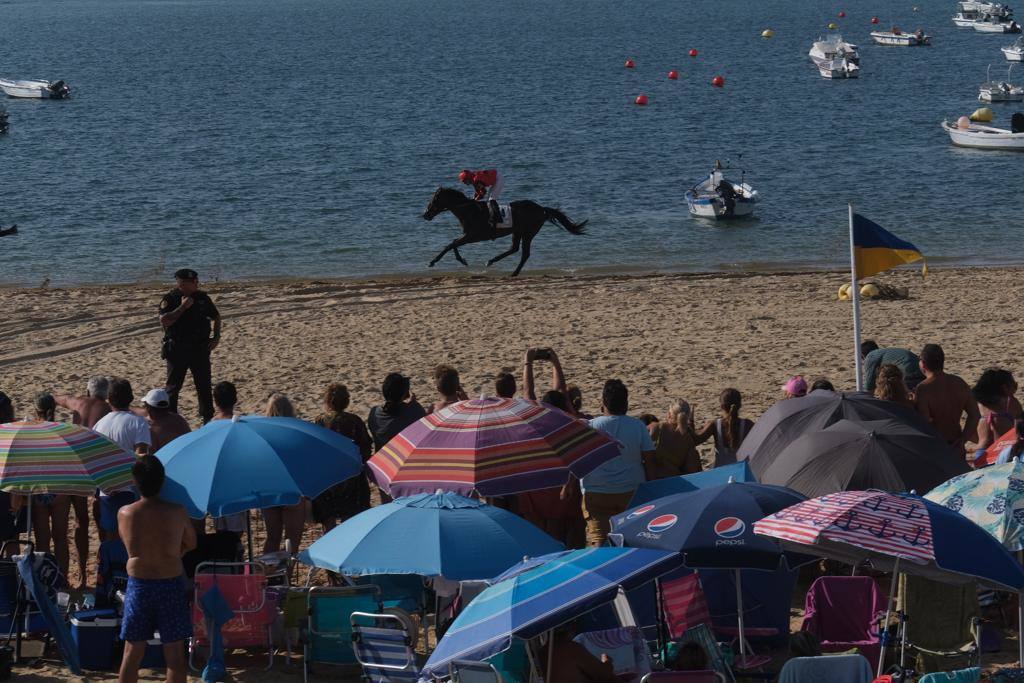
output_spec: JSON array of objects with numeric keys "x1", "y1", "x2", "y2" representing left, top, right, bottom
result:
[{"x1": 421, "y1": 548, "x2": 682, "y2": 680}]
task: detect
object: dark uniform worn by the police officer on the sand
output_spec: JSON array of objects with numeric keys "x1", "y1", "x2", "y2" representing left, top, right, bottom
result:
[{"x1": 160, "y1": 288, "x2": 220, "y2": 424}]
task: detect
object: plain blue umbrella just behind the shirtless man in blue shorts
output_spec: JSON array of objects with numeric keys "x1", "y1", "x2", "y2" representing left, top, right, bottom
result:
[{"x1": 151, "y1": 416, "x2": 362, "y2": 518}]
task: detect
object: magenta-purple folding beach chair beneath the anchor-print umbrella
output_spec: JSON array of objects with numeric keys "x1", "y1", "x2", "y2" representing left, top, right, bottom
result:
[{"x1": 801, "y1": 577, "x2": 886, "y2": 671}]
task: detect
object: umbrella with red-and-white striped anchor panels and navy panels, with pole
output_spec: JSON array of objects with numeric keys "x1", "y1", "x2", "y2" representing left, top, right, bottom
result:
[{"x1": 754, "y1": 490, "x2": 1024, "y2": 674}]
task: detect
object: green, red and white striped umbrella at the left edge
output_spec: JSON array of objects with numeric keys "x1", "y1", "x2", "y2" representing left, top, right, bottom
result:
[{"x1": 0, "y1": 421, "x2": 135, "y2": 496}]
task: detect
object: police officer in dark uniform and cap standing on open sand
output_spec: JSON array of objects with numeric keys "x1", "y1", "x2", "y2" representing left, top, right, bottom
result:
[{"x1": 160, "y1": 268, "x2": 220, "y2": 424}]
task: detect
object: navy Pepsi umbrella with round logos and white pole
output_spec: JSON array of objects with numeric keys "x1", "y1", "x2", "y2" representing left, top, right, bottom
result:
[{"x1": 609, "y1": 481, "x2": 813, "y2": 659}]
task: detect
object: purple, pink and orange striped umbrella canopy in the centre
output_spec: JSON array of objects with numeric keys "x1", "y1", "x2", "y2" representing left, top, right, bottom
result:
[{"x1": 368, "y1": 397, "x2": 618, "y2": 496}]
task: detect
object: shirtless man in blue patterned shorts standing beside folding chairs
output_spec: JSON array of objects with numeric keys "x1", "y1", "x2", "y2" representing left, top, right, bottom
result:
[{"x1": 118, "y1": 456, "x2": 196, "y2": 683}]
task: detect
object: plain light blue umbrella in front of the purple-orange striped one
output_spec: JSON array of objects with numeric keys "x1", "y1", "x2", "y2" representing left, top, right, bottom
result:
[{"x1": 299, "y1": 493, "x2": 563, "y2": 581}]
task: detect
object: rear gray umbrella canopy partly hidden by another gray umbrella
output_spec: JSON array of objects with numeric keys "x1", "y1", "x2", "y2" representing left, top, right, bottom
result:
[{"x1": 738, "y1": 389, "x2": 938, "y2": 481}]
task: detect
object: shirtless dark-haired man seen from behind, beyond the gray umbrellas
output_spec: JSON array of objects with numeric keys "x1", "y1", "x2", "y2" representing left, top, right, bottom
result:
[{"x1": 914, "y1": 344, "x2": 981, "y2": 457}]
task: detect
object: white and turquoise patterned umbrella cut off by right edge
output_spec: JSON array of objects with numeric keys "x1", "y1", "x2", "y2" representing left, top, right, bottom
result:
[{"x1": 925, "y1": 460, "x2": 1024, "y2": 551}]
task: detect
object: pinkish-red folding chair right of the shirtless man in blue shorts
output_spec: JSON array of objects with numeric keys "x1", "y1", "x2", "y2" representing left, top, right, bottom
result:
[{"x1": 188, "y1": 562, "x2": 278, "y2": 671}]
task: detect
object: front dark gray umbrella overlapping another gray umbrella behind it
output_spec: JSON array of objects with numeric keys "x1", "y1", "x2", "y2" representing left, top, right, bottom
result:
[{"x1": 760, "y1": 419, "x2": 970, "y2": 498}]
